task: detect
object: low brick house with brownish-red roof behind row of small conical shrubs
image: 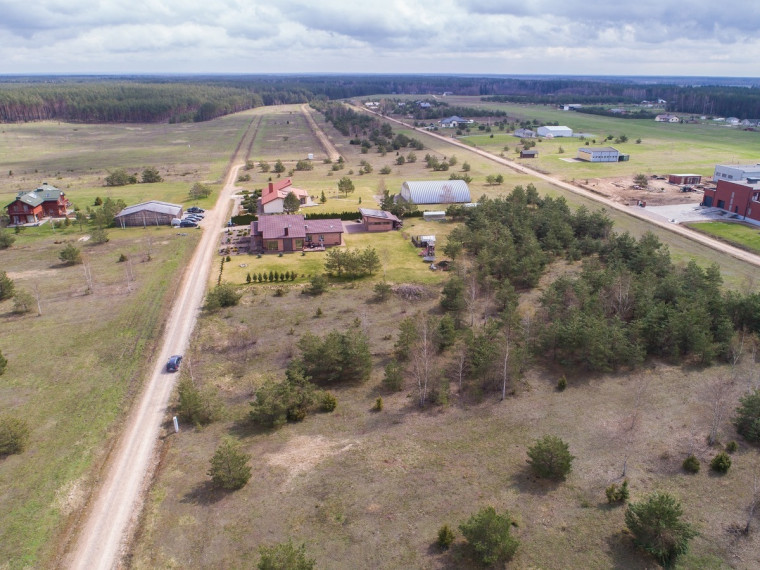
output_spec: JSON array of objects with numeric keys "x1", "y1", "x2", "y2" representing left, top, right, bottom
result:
[{"x1": 251, "y1": 214, "x2": 343, "y2": 253}]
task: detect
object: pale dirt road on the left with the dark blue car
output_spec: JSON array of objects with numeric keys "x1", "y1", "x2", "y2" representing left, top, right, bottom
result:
[{"x1": 66, "y1": 160, "x2": 241, "y2": 570}]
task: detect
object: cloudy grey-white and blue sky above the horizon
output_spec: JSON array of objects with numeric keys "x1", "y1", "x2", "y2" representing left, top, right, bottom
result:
[{"x1": 0, "y1": 0, "x2": 760, "y2": 77}]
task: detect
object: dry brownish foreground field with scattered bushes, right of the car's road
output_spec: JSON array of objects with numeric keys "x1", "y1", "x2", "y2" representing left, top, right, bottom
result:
[{"x1": 132, "y1": 284, "x2": 760, "y2": 570}]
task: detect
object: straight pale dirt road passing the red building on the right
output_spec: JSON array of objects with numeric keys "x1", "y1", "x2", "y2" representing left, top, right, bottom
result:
[{"x1": 354, "y1": 105, "x2": 760, "y2": 267}]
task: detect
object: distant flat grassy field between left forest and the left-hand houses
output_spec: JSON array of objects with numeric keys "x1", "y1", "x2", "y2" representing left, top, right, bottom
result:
[{"x1": 0, "y1": 111, "x2": 257, "y2": 213}]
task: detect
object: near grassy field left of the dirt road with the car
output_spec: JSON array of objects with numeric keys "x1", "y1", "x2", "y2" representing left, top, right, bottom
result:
[{"x1": 0, "y1": 226, "x2": 199, "y2": 568}]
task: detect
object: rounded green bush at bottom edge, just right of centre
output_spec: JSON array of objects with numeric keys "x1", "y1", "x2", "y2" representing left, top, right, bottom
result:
[{"x1": 459, "y1": 507, "x2": 519, "y2": 565}]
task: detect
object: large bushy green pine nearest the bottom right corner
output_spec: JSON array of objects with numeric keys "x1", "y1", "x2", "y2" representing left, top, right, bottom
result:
[{"x1": 625, "y1": 492, "x2": 697, "y2": 565}]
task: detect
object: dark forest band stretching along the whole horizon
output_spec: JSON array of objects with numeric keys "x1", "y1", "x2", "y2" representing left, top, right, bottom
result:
[{"x1": 0, "y1": 75, "x2": 760, "y2": 123}]
